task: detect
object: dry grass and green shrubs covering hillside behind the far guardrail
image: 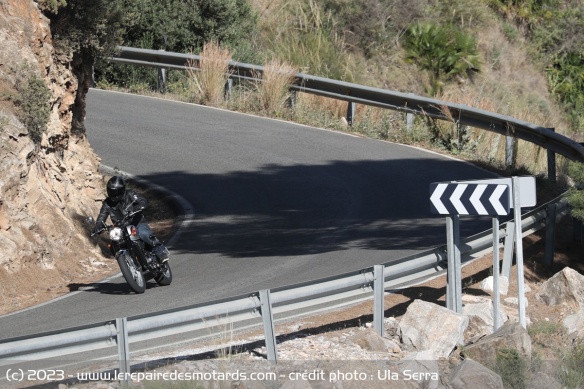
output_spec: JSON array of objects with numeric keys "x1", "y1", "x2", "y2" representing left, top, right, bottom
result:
[{"x1": 84, "y1": 0, "x2": 584, "y2": 179}]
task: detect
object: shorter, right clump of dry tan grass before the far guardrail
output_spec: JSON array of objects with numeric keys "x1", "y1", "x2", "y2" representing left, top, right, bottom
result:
[{"x1": 257, "y1": 60, "x2": 297, "y2": 113}]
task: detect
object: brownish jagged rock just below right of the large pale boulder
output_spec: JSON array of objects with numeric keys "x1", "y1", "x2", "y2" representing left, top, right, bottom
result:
[{"x1": 464, "y1": 322, "x2": 531, "y2": 365}]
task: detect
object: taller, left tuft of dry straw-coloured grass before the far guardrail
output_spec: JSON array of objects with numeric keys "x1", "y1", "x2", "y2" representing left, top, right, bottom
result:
[{"x1": 187, "y1": 42, "x2": 231, "y2": 107}]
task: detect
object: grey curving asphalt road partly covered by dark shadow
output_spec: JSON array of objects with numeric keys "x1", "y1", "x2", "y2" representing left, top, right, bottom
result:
[{"x1": 0, "y1": 89, "x2": 493, "y2": 338}]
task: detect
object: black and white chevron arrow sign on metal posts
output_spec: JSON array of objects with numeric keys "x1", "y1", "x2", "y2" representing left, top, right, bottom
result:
[{"x1": 430, "y1": 182, "x2": 510, "y2": 216}]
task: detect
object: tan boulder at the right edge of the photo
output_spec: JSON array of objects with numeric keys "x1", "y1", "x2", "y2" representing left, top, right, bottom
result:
[{"x1": 536, "y1": 267, "x2": 584, "y2": 311}]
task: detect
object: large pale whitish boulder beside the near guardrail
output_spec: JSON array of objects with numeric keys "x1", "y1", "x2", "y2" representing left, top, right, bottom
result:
[{"x1": 400, "y1": 300, "x2": 469, "y2": 359}]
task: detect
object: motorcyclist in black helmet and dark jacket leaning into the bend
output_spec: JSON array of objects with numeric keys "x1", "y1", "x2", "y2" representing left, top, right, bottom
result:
[{"x1": 93, "y1": 176, "x2": 168, "y2": 263}]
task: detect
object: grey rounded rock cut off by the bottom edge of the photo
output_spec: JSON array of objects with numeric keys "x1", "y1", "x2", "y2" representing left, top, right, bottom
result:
[{"x1": 450, "y1": 359, "x2": 505, "y2": 389}]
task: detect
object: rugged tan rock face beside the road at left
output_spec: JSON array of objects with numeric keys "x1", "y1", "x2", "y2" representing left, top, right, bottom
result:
[{"x1": 0, "y1": 0, "x2": 103, "y2": 313}]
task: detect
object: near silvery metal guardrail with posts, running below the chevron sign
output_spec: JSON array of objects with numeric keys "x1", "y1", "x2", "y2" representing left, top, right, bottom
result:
[{"x1": 0, "y1": 198, "x2": 568, "y2": 372}]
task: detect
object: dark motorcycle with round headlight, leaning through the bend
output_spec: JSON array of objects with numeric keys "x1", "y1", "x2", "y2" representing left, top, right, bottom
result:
[{"x1": 87, "y1": 210, "x2": 172, "y2": 293}]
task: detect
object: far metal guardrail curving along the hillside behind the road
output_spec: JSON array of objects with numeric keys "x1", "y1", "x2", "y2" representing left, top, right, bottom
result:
[{"x1": 110, "y1": 46, "x2": 584, "y2": 162}]
